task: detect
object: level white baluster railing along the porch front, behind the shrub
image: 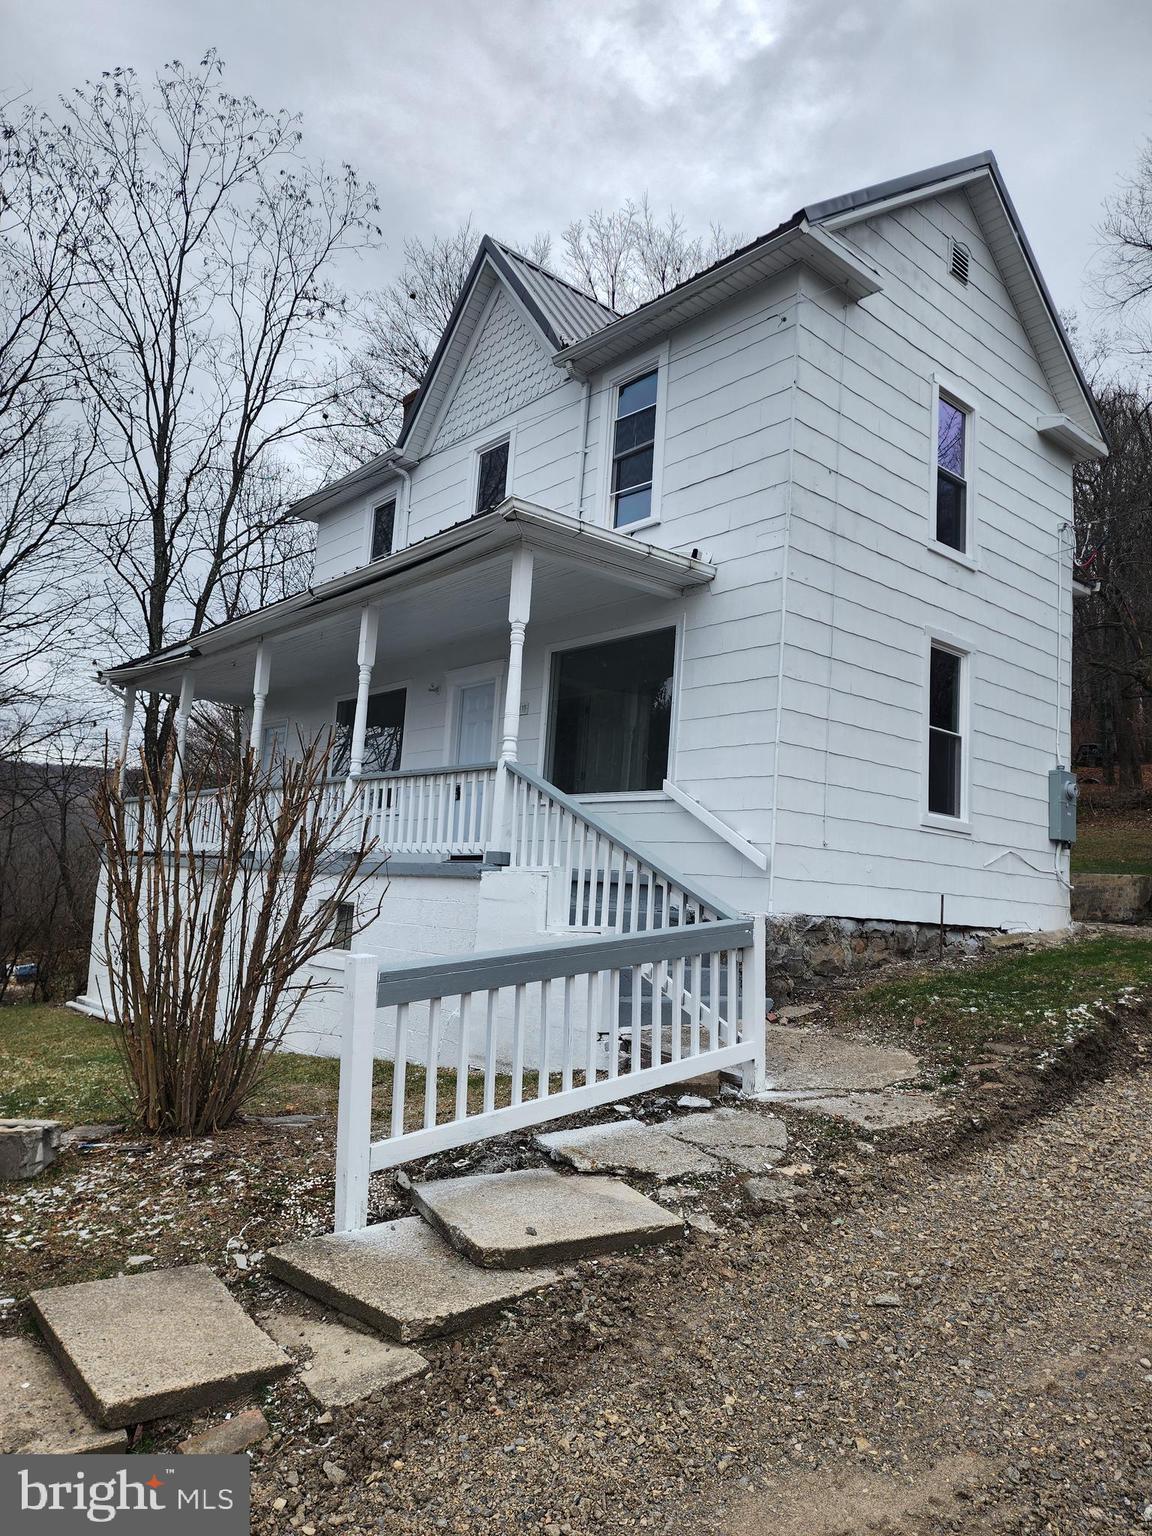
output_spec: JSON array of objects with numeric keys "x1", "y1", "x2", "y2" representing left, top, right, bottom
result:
[{"x1": 187, "y1": 763, "x2": 496, "y2": 857}]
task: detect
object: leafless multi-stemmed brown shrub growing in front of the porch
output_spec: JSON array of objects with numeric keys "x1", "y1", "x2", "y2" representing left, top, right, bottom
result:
[{"x1": 97, "y1": 742, "x2": 388, "y2": 1135}]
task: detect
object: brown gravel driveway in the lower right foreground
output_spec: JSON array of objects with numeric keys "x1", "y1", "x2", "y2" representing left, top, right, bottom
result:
[{"x1": 255, "y1": 1050, "x2": 1152, "y2": 1536}]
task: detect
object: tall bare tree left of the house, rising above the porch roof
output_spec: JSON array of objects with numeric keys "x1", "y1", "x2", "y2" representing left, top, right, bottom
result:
[{"x1": 6, "y1": 52, "x2": 379, "y2": 766}]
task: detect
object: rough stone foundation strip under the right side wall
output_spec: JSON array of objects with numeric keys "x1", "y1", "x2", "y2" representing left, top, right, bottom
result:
[{"x1": 768, "y1": 917, "x2": 992, "y2": 997}]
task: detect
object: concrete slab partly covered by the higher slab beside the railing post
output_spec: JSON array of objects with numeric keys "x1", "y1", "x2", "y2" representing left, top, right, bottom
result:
[{"x1": 264, "y1": 1217, "x2": 556, "y2": 1342}]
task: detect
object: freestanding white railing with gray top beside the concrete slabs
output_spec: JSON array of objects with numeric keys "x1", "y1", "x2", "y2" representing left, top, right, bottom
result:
[{"x1": 335, "y1": 917, "x2": 765, "y2": 1232}]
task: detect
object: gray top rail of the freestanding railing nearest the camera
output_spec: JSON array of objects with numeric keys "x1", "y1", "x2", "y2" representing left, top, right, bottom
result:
[{"x1": 376, "y1": 919, "x2": 754, "y2": 1008}]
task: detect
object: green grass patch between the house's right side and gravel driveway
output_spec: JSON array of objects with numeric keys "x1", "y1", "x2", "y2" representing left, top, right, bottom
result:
[{"x1": 839, "y1": 931, "x2": 1152, "y2": 1054}]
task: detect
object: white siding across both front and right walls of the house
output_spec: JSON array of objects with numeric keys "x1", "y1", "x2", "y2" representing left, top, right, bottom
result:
[{"x1": 302, "y1": 202, "x2": 1071, "y2": 928}]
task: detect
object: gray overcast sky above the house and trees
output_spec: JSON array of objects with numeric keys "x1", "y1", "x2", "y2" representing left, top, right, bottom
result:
[{"x1": 0, "y1": 0, "x2": 1152, "y2": 317}]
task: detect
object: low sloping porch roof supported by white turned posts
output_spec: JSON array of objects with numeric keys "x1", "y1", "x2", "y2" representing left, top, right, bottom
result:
[{"x1": 108, "y1": 498, "x2": 716, "y2": 703}]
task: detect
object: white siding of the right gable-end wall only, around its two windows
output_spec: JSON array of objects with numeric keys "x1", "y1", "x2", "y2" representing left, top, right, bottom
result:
[{"x1": 773, "y1": 194, "x2": 1071, "y2": 928}]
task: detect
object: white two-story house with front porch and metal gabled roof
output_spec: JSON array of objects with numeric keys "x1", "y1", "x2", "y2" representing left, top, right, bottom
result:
[{"x1": 79, "y1": 154, "x2": 1106, "y2": 1050}]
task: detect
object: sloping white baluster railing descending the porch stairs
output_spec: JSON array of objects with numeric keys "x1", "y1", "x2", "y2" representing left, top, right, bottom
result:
[{"x1": 507, "y1": 763, "x2": 734, "y2": 934}]
